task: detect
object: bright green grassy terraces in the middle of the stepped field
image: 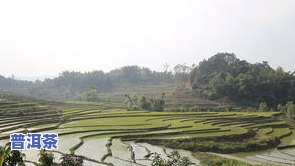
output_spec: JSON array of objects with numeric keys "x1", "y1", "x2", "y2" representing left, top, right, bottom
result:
[{"x1": 45, "y1": 103, "x2": 286, "y2": 156}]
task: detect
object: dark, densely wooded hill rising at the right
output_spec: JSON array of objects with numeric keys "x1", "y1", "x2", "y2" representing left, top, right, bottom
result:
[{"x1": 189, "y1": 53, "x2": 295, "y2": 106}]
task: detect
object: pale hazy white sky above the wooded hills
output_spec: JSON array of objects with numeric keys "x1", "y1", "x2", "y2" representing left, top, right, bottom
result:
[{"x1": 0, "y1": 0, "x2": 295, "y2": 78}]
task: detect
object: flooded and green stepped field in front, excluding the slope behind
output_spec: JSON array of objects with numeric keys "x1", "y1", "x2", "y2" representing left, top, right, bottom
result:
[{"x1": 0, "y1": 95, "x2": 295, "y2": 166}]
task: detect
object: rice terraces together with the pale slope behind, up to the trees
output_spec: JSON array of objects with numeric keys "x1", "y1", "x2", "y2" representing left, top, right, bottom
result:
[{"x1": 0, "y1": 54, "x2": 295, "y2": 166}]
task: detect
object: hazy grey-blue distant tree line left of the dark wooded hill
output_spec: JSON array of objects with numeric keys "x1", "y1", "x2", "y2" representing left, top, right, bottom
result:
[{"x1": 0, "y1": 66, "x2": 175, "y2": 100}]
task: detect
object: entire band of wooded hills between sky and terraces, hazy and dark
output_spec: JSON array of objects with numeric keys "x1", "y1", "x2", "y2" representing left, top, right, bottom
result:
[{"x1": 0, "y1": 53, "x2": 295, "y2": 106}]
